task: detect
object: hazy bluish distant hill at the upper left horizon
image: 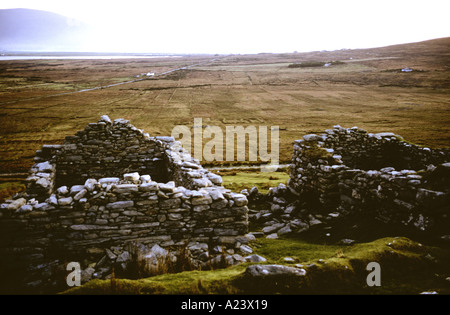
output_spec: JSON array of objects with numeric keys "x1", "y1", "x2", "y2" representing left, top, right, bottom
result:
[{"x1": 0, "y1": 9, "x2": 90, "y2": 51}]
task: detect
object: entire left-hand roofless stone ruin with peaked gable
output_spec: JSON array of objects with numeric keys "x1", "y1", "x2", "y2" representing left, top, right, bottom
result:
[{"x1": 0, "y1": 116, "x2": 251, "y2": 291}]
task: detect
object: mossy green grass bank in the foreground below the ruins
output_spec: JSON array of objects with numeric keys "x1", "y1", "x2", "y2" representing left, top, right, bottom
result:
[{"x1": 64, "y1": 237, "x2": 450, "y2": 294}]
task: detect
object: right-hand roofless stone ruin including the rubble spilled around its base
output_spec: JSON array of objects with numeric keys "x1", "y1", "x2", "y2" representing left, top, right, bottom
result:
[{"x1": 244, "y1": 126, "x2": 450, "y2": 243}]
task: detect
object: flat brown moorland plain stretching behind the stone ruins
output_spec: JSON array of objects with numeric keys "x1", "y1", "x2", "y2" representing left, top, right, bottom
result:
[{"x1": 0, "y1": 38, "x2": 450, "y2": 179}]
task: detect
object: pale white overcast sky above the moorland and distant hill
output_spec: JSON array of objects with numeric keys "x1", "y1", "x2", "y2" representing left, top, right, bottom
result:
[{"x1": 0, "y1": 0, "x2": 450, "y2": 53}]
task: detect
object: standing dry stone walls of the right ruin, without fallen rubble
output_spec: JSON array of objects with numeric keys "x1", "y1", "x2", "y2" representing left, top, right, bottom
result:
[{"x1": 289, "y1": 126, "x2": 450, "y2": 235}]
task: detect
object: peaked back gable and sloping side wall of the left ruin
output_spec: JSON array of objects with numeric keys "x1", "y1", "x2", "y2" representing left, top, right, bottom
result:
[{"x1": 27, "y1": 116, "x2": 222, "y2": 201}]
